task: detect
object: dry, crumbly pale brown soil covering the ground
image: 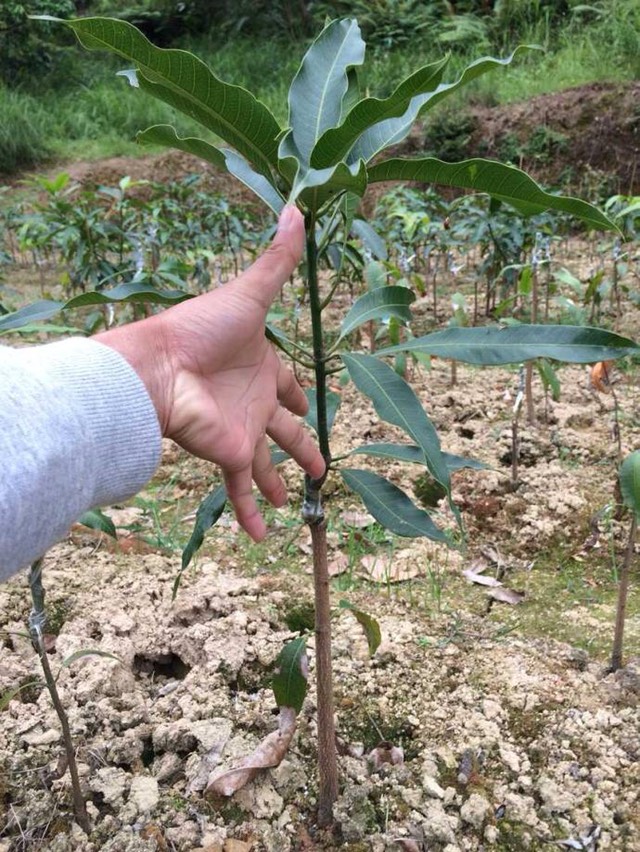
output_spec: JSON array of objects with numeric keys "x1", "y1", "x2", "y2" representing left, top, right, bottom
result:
[{"x1": 0, "y1": 352, "x2": 640, "y2": 852}]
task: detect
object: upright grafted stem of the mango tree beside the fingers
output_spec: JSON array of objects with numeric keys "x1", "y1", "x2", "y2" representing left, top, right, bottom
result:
[{"x1": 302, "y1": 213, "x2": 338, "y2": 828}]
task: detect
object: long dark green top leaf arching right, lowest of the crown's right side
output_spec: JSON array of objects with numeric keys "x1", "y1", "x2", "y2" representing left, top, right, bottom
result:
[{"x1": 368, "y1": 157, "x2": 617, "y2": 231}]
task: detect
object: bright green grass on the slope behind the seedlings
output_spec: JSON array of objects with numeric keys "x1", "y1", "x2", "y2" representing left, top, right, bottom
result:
[{"x1": 0, "y1": 4, "x2": 640, "y2": 173}]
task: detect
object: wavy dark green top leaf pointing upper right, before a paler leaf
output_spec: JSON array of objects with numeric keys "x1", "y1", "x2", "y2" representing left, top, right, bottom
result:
[{"x1": 311, "y1": 56, "x2": 449, "y2": 169}]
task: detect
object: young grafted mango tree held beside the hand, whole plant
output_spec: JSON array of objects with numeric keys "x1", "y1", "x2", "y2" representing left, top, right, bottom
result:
[{"x1": 41, "y1": 13, "x2": 638, "y2": 826}]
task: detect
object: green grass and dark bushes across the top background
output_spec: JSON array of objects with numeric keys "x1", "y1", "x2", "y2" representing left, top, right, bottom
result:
[{"x1": 0, "y1": 0, "x2": 640, "y2": 174}]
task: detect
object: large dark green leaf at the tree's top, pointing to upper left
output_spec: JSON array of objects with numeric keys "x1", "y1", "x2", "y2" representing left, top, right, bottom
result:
[{"x1": 48, "y1": 16, "x2": 280, "y2": 175}]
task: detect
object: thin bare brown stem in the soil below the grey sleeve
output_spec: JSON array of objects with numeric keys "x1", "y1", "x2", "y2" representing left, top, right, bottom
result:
[{"x1": 29, "y1": 559, "x2": 91, "y2": 834}]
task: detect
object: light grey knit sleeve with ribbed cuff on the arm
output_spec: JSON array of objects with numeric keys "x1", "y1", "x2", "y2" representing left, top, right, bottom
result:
[{"x1": 0, "y1": 338, "x2": 161, "y2": 579}]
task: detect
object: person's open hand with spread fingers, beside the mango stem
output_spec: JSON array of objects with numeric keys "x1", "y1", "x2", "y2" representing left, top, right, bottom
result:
[{"x1": 96, "y1": 206, "x2": 325, "y2": 541}]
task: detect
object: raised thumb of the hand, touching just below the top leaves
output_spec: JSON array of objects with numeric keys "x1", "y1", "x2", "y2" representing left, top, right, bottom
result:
[{"x1": 236, "y1": 204, "x2": 305, "y2": 311}]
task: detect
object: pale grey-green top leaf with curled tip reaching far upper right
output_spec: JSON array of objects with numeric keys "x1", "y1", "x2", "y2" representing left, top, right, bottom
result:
[{"x1": 349, "y1": 45, "x2": 535, "y2": 162}]
